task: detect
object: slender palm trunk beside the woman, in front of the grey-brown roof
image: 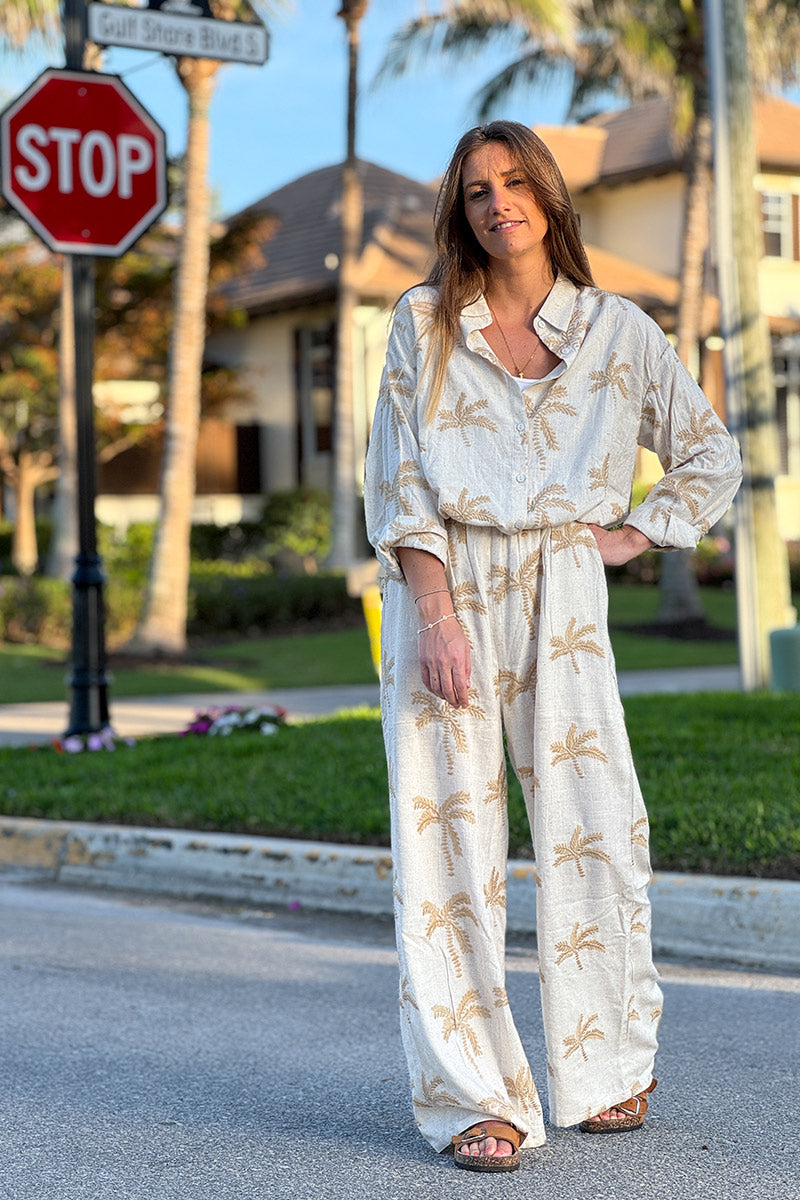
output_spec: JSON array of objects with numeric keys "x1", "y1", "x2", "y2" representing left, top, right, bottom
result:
[{"x1": 330, "y1": 0, "x2": 367, "y2": 566}]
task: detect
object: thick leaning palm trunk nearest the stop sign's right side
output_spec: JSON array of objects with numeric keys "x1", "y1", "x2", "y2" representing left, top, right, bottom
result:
[{"x1": 131, "y1": 59, "x2": 219, "y2": 654}]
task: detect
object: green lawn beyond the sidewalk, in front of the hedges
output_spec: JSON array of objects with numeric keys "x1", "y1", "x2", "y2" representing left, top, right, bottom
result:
[{"x1": 0, "y1": 584, "x2": 753, "y2": 703}]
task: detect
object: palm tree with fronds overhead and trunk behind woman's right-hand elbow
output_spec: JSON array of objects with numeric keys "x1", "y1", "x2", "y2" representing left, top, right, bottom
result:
[{"x1": 379, "y1": 0, "x2": 800, "y2": 622}]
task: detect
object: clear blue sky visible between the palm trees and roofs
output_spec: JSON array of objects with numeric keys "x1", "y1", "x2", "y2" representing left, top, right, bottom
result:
[{"x1": 0, "y1": 0, "x2": 575, "y2": 215}]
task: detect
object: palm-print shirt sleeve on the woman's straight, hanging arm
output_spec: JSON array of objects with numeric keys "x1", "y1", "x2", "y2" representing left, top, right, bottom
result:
[{"x1": 363, "y1": 302, "x2": 447, "y2": 580}]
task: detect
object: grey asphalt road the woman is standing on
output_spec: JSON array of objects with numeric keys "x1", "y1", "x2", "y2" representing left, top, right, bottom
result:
[{"x1": 0, "y1": 883, "x2": 800, "y2": 1200}]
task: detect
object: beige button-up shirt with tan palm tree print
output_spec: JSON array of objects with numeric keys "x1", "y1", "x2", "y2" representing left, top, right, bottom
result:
[{"x1": 365, "y1": 275, "x2": 741, "y2": 580}]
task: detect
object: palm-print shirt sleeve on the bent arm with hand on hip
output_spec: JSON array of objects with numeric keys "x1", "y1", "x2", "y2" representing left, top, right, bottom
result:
[{"x1": 625, "y1": 344, "x2": 741, "y2": 550}]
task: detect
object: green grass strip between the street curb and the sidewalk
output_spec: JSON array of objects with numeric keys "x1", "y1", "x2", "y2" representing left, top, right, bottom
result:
[{"x1": 0, "y1": 694, "x2": 800, "y2": 880}]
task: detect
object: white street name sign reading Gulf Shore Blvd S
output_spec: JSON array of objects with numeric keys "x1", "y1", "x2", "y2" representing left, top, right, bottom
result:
[{"x1": 86, "y1": 0, "x2": 270, "y2": 66}]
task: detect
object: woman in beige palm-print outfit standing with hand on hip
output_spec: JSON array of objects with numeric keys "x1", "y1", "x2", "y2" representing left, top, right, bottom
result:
[{"x1": 366, "y1": 121, "x2": 740, "y2": 1170}]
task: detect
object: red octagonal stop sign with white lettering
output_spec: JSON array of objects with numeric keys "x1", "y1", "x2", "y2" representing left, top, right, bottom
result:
[{"x1": 0, "y1": 70, "x2": 167, "y2": 254}]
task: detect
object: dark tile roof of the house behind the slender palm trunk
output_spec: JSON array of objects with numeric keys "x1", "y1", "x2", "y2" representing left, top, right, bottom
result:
[{"x1": 224, "y1": 161, "x2": 437, "y2": 312}]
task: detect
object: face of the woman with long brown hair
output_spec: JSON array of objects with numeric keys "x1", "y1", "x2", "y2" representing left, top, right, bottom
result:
[{"x1": 462, "y1": 142, "x2": 549, "y2": 262}]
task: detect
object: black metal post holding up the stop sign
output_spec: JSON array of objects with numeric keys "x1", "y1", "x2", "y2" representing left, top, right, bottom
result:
[{"x1": 64, "y1": 0, "x2": 109, "y2": 733}]
